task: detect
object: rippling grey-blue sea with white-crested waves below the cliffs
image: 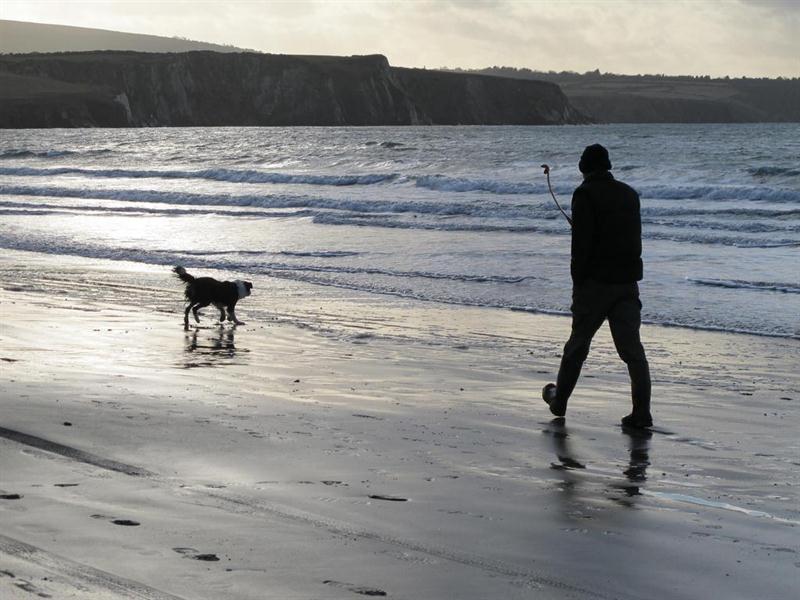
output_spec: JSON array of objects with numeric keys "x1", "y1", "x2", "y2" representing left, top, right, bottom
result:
[{"x1": 0, "y1": 124, "x2": 800, "y2": 339}]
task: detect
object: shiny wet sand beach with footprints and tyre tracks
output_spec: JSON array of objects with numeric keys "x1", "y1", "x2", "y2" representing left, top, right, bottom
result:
[{"x1": 0, "y1": 252, "x2": 800, "y2": 599}]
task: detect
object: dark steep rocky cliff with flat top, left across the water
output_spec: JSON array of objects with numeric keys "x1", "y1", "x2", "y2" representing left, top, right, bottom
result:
[{"x1": 0, "y1": 52, "x2": 586, "y2": 128}]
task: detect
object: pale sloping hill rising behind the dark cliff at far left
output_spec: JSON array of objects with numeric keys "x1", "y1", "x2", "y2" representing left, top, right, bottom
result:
[{"x1": 0, "y1": 20, "x2": 250, "y2": 54}]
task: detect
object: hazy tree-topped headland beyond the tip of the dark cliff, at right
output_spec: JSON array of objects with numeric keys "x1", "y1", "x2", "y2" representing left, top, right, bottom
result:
[{"x1": 452, "y1": 67, "x2": 800, "y2": 123}]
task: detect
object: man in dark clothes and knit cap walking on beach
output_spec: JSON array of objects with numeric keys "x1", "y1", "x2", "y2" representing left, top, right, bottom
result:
[{"x1": 542, "y1": 144, "x2": 653, "y2": 428}]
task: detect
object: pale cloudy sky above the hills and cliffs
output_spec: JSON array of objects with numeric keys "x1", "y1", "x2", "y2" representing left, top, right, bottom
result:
[{"x1": 0, "y1": 0, "x2": 800, "y2": 77}]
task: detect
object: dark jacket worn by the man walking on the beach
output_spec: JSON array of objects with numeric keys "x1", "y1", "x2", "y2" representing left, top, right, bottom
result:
[{"x1": 570, "y1": 171, "x2": 642, "y2": 285}]
